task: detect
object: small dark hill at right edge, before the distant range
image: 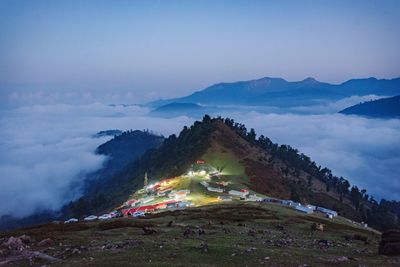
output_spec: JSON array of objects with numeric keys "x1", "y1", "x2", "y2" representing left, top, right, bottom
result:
[{"x1": 339, "y1": 95, "x2": 400, "y2": 118}]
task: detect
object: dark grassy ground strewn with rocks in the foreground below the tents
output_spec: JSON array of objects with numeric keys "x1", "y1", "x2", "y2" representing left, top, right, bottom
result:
[{"x1": 0, "y1": 203, "x2": 400, "y2": 266}]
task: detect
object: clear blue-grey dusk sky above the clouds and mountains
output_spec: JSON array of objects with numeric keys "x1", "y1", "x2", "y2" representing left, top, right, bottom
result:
[{"x1": 0, "y1": 1, "x2": 400, "y2": 102}]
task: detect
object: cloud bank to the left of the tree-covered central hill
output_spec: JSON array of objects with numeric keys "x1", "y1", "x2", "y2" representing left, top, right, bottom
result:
[{"x1": 0, "y1": 103, "x2": 192, "y2": 217}]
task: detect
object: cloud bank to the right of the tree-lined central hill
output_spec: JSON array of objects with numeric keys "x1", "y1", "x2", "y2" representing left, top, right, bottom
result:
[{"x1": 225, "y1": 112, "x2": 400, "y2": 200}]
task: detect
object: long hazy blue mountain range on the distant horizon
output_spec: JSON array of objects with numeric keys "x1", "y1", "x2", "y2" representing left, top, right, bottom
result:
[{"x1": 149, "y1": 77, "x2": 400, "y2": 107}]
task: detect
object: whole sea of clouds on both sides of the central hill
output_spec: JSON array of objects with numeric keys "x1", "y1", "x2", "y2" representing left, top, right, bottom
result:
[{"x1": 0, "y1": 99, "x2": 400, "y2": 217}]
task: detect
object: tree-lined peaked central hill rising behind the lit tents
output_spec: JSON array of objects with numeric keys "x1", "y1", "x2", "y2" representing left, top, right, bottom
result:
[{"x1": 64, "y1": 115, "x2": 400, "y2": 232}]
